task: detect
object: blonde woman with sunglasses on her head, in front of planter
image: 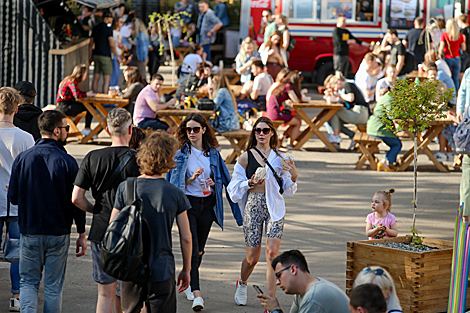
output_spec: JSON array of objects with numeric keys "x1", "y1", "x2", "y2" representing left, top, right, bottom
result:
[{"x1": 353, "y1": 266, "x2": 402, "y2": 313}]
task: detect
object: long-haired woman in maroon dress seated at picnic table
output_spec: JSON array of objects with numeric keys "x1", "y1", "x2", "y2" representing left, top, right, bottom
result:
[{"x1": 266, "y1": 71, "x2": 304, "y2": 150}]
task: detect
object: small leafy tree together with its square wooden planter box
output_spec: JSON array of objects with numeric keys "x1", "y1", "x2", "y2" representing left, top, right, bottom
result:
[{"x1": 346, "y1": 79, "x2": 453, "y2": 312}]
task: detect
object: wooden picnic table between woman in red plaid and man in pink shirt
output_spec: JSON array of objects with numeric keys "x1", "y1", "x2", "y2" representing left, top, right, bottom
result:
[{"x1": 77, "y1": 93, "x2": 129, "y2": 143}]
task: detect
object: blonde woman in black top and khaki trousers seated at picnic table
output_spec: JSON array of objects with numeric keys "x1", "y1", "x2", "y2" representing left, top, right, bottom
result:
[{"x1": 328, "y1": 72, "x2": 369, "y2": 145}]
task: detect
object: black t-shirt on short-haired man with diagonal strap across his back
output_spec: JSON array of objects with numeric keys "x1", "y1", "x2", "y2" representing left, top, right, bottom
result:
[{"x1": 74, "y1": 147, "x2": 140, "y2": 242}]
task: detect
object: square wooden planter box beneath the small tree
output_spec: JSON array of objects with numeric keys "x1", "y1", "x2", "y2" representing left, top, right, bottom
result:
[{"x1": 346, "y1": 236, "x2": 470, "y2": 313}]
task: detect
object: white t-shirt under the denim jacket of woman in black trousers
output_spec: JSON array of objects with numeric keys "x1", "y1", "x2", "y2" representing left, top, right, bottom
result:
[{"x1": 184, "y1": 146, "x2": 211, "y2": 197}]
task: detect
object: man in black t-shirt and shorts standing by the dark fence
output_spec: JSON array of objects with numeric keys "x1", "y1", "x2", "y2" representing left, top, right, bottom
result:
[{"x1": 89, "y1": 10, "x2": 119, "y2": 93}]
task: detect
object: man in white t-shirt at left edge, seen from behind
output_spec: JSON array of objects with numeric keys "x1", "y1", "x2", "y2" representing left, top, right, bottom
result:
[{"x1": 0, "y1": 87, "x2": 34, "y2": 312}]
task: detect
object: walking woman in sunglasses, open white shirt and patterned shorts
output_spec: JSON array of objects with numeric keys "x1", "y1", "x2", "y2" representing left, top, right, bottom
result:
[{"x1": 227, "y1": 117, "x2": 299, "y2": 305}]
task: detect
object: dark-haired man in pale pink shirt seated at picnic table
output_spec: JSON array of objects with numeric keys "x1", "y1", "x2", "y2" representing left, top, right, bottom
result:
[{"x1": 134, "y1": 73, "x2": 176, "y2": 134}]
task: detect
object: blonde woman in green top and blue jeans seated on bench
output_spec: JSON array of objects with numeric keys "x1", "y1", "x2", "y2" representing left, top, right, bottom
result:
[{"x1": 367, "y1": 92, "x2": 402, "y2": 172}]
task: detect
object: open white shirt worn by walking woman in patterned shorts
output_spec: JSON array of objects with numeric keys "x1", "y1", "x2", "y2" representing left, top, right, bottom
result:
[{"x1": 227, "y1": 150, "x2": 297, "y2": 222}]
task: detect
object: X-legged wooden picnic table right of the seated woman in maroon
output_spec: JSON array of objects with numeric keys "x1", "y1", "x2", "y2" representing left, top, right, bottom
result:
[{"x1": 292, "y1": 100, "x2": 343, "y2": 152}]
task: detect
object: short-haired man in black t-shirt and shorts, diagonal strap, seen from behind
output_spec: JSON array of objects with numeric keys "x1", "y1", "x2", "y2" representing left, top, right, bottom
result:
[{"x1": 72, "y1": 108, "x2": 140, "y2": 312}]
